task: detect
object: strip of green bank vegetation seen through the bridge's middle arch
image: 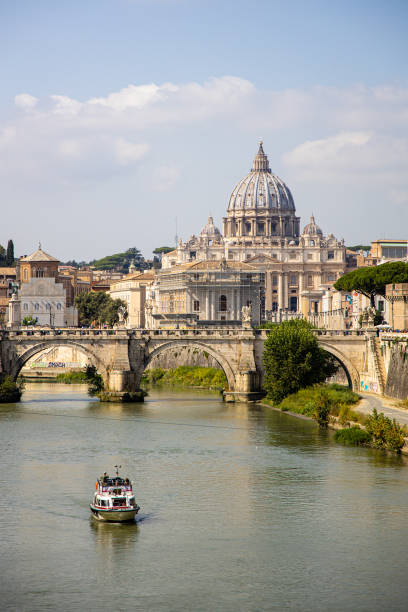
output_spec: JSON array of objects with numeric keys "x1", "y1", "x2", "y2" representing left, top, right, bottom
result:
[{"x1": 141, "y1": 366, "x2": 227, "y2": 390}]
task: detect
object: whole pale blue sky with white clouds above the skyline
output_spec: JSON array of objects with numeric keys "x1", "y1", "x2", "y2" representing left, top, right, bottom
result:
[{"x1": 0, "y1": 0, "x2": 408, "y2": 261}]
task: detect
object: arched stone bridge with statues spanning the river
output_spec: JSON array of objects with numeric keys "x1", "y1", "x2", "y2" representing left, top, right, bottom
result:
[{"x1": 0, "y1": 327, "x2": 396, "y2": 401}]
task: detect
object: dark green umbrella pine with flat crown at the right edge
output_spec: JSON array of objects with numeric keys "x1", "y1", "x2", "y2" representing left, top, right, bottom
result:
[{"x1": 334, "y1": 261, "x2": 408, "y2": 307}]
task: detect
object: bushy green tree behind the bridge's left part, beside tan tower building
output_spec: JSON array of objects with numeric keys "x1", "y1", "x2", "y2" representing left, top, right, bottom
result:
[{"x1": 75, "y1": 291, "x2": 128, "y2": 326}]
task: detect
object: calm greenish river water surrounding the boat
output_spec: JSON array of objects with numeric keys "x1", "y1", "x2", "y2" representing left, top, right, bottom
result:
[{"x1": 0, "y1": 384, "x2": 408, "y2": 612}]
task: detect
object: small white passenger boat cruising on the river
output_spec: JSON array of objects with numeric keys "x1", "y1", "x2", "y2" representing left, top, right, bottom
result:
[{"x1": 90, "y1": 465, "x2": 140, "y2": 523}]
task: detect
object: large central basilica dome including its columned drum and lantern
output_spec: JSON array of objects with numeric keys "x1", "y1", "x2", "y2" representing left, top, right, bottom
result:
[{"x1": 223, "y1": 141, "x2": 300, "y2": 241}]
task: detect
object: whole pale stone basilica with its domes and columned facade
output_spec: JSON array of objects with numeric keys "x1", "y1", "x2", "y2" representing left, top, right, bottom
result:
[{"x1": 163, "y1": 142, "x2": 346, "y2": 320}]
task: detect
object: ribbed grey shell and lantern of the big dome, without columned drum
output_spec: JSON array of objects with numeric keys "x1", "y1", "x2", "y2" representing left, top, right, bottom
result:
[{"x1": 228, "y1": 140, "x2": 295, "y2": 211}]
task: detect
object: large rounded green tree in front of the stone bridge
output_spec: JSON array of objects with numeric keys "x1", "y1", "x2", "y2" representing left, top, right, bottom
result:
[{"x1": 263, "y1": 319, "x2": 337, "y2": 403}]
